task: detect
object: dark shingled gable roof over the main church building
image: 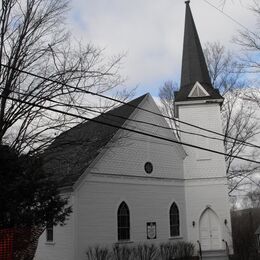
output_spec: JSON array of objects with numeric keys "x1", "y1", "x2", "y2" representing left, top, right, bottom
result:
[{"x1": 44, "y1": 94, "x2": 148, "y2": 187}]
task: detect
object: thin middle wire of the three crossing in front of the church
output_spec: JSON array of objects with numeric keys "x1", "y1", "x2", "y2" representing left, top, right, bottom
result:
[{"x1": 3, "y1": 87, "x2": 260, "y2": 148}]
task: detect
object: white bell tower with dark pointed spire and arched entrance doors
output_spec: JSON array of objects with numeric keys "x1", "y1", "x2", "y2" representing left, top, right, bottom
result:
[{"x1": 175, "y1": 1, "x2": 232, "y2": 259}]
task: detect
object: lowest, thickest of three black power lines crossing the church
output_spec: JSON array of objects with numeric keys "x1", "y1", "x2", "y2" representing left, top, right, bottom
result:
[{"x1": 0, "y1": 94, "x2": 260, "y2": 164}]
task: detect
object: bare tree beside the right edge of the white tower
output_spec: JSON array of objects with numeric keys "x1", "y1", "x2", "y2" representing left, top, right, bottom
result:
[{"x1": 222, "y1": 89, "x2": 259, "y2": 193}]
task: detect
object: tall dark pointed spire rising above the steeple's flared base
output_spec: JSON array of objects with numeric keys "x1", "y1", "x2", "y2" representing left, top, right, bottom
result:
[{"x1": 181, "y1": 1, "x2": 212, "y2": 88}]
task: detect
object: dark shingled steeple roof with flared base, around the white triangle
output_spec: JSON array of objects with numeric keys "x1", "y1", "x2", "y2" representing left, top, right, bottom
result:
[{"x1": 175, "y1": 1, "x2": 222, "y2": 101}]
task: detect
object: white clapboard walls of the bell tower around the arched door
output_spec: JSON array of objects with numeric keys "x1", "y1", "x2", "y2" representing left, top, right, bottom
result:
[{"x1": 179, "y1": 103, "x2": 232, "y2": 252}]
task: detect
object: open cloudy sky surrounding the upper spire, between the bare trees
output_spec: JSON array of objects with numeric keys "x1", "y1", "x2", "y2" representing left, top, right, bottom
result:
[{"x1": 68, "y1": 0, "x2": 257, "y2": 97}]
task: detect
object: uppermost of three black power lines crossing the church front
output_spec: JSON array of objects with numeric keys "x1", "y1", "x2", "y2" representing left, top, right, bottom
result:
[{"x1": 0, "y1": 63, "x2": 260, "y2": 148}]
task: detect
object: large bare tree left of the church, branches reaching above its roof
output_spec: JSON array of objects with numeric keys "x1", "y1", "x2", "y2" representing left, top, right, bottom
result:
[{"x1": 0, "y1": 0, "x2": 133, "y2": 152}]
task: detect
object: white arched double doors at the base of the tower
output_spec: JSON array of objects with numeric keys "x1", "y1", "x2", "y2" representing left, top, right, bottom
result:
[{"x1": 199, "y1": 208, "x2": 221, "y2": 250}]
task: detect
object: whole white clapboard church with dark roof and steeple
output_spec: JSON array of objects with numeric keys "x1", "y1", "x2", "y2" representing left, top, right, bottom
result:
[{"x1": 35, "y1": 1, "x2": 232, "y2": 260}]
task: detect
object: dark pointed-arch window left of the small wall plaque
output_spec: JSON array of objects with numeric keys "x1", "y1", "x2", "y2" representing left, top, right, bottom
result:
[{"x1": 117, "y1": 202, "x2": 130, "y2": 240}]
